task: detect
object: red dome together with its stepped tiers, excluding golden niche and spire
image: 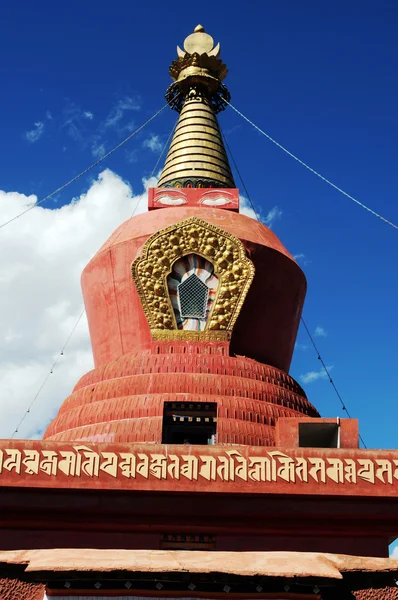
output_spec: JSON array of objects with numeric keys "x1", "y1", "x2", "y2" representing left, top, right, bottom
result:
[{"x1": 44, "y1": 207, "x2": 318, "y2": 445}]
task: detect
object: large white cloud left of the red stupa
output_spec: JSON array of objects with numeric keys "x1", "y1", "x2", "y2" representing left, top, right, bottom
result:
[{"x1": 0, "y1": 170, "x2": 152, "y2": 437}]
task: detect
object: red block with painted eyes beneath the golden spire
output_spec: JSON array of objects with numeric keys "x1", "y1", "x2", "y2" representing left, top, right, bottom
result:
[{"x1": 148, "y1": 188, "x2": 239, "y2": 212}]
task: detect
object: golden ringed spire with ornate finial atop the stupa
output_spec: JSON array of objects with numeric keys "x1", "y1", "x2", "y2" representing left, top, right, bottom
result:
[{"x1": 158, "y1": 25, "x2": 236, "y2": 188}]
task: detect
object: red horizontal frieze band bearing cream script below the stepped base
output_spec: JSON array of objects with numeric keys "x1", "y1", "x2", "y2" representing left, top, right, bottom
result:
[{"x1": 0, "y1": 440, "x2": 398, "y2": 498}]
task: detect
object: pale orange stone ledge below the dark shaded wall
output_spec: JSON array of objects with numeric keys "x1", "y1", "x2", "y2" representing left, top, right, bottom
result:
[{"x1": 0, "y1": 548, "x2": 398, "y2": 580}]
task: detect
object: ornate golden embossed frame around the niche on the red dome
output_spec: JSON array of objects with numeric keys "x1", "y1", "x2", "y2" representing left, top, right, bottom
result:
[{"x1": 131, "y1": 217, "x2": 254, "y2": 341}]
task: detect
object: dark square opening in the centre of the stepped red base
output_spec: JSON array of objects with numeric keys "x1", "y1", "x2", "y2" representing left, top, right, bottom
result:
[{"x1": 162, "y1": 402, "x2": 217, "y2": 446}]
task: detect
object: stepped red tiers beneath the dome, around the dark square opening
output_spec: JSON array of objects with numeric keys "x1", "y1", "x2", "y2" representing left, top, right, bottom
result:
[{"x1": 43, "y1": 342, "x2": 319, "y2": 446}]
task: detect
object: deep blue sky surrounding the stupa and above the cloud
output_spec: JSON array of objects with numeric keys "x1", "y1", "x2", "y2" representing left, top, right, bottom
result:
[{"x1": 0, "y1": 0, "x2": 398, "y2": 448}]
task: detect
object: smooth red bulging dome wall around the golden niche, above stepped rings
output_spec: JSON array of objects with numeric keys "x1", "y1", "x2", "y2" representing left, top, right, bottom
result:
[{"x1": 82, "y1": 207, "x2": 306, "y2": 371}]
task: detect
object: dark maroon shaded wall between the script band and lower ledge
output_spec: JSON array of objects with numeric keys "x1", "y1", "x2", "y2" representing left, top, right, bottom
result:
[{"x1": 0, "y1": 462, "x2": 398, "y2": 556}]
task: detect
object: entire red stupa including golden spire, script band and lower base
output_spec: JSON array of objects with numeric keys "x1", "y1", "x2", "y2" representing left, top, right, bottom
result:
[{"x1": 0, "y1": 25, "x2": 398, "y2": 600}]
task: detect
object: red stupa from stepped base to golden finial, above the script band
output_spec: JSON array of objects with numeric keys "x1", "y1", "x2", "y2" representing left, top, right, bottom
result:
[{"x1": 44, "y1": 26, "x2": 319, "y2": 446}]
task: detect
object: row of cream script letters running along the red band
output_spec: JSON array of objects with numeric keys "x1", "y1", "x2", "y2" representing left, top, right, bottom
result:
[{"x1": 0, "y1": 444, "x2": 398, "y2": 485}]
